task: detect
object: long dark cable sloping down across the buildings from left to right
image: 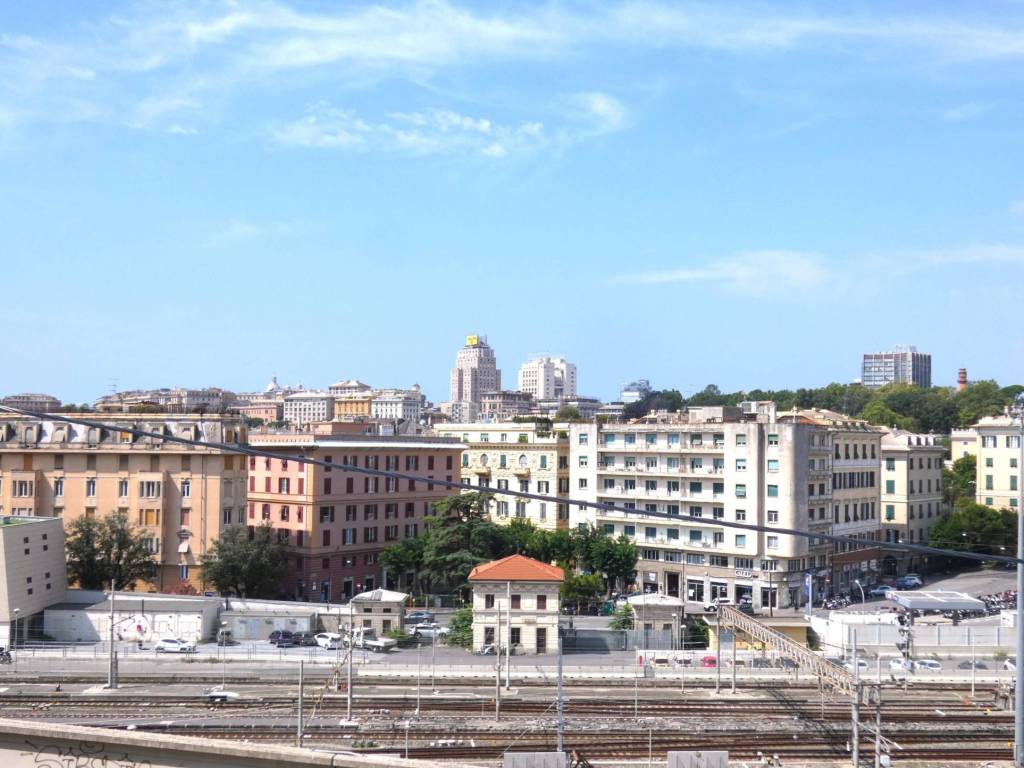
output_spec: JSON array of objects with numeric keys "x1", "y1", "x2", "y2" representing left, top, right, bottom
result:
[{"x1": 0, "y1": 404, "x2": 1024, "y2": 564}]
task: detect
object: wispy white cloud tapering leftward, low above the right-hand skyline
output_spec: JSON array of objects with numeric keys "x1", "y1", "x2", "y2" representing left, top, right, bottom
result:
[{"x1": 612, "y1": 256, "x2": 829, "y2": 294}]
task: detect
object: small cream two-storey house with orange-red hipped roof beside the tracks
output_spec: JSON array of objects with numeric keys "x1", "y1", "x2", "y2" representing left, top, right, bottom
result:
[{"x1": 469, "y1": 555, "x2": 565, "y2": 654}]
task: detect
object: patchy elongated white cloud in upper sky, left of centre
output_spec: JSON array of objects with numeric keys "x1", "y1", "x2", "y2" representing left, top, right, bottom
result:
[{"x1": 271, "y1": 103, "x2": 547, "y2": 158}]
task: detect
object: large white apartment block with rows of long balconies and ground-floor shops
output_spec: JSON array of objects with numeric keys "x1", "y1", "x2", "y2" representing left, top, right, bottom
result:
[{"x1": 569, "y1": 403, "x2": 833, "y2": 607}]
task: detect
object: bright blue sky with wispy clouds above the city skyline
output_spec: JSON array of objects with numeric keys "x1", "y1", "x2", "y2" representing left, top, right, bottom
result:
[{"x1": 0, "y1": 0, "x2": 1024, "y2": 400}]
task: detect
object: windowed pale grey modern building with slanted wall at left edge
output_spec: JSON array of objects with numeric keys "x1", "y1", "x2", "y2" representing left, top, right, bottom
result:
[{"x1": 0, "y1": 515, "x2": 68, "y2": 647}]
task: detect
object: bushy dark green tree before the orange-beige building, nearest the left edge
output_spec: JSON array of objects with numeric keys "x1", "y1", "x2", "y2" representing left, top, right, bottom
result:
[{"x1": 65, "y1": 512, "x2": 156, "y2": 591}]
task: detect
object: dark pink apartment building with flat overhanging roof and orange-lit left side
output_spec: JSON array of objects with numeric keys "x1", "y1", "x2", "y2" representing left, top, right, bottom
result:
[{"x1": 247, "y1": 432, "x2": 466, "y2": 602}]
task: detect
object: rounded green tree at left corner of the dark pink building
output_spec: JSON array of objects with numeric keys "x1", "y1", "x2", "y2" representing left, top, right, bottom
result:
[{"x1": 202, "y1": 523, "x2": 287, "y2": 598}]
